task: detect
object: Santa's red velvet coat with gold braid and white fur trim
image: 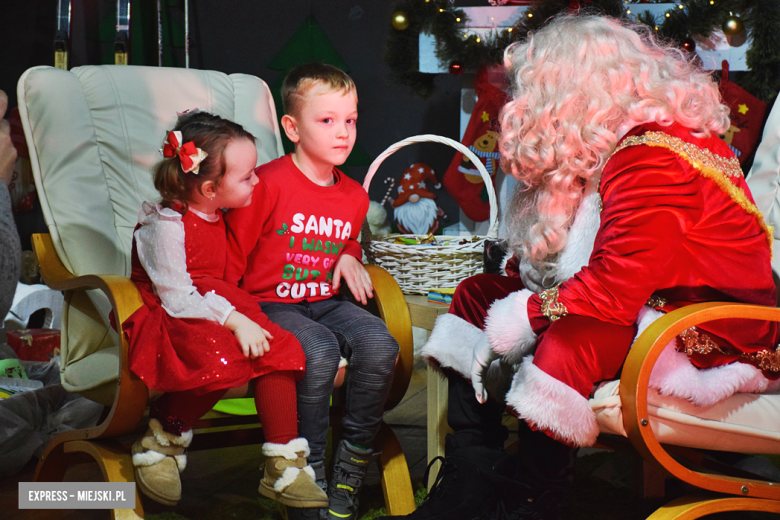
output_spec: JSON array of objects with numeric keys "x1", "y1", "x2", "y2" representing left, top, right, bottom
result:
[{"x1": 423, "y1": 123, "x2": 780, "y2": 445}]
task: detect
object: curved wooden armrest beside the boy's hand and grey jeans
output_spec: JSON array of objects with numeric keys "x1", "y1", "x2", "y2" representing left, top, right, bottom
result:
[{"x1": 366, "y1": 265, "x2": 414, "y2": 410}]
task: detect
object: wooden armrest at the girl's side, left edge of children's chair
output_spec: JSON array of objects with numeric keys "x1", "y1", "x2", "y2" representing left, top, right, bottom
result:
[{"x1": 32, "y1": 234, "x2": 149, "y2": 439}]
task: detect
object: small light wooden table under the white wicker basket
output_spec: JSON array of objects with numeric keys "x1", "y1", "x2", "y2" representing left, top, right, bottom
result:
[{"x1": 405, "y1": 294, "x2": 452, "y2": 479}]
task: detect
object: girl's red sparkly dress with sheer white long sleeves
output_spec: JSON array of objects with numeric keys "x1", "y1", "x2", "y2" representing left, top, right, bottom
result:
[{"x1": 124, "y1": 202, "x2": 306, "y2": 393}]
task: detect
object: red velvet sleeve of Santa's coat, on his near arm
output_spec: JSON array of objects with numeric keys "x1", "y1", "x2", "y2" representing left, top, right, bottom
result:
[{"x1": 528, "y1": 145, "x2": 703, "y2": 334}]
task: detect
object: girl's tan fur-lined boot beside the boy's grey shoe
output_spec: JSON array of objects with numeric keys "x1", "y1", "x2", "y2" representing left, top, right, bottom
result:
[{"x1": 257, "y1": 437, "x2": 328, "y2": 508}]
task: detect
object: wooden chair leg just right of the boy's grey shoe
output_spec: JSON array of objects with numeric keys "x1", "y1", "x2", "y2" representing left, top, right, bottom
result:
[{"x1": 375, "y1": 421, "x2": 415, "y2": 516}]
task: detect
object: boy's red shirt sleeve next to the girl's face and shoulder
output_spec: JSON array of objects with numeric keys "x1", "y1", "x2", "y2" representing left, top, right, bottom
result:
[{"x1": 225, "y1": 179, "x2": 274, "y2": 285}]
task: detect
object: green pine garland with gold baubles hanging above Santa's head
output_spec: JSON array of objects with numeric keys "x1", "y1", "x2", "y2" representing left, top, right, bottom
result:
[{"x1": 385, "y1": 0, "x2": 780, "y2": 102}]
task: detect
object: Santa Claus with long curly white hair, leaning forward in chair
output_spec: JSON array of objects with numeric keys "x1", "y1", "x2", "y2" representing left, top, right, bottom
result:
[{"x1": 382, "y1": 16, "x2": 780, "y2": 519}]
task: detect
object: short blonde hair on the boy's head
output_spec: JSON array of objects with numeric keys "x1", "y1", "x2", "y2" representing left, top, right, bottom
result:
[{"x1": 282, "y1": 63, "x2": 357, "y2": 116}]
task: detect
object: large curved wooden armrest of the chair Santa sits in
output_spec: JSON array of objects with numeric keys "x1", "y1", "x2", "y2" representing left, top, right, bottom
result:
[{"x1": 620, "y1": 302, "x2": 780, "y2": 500}]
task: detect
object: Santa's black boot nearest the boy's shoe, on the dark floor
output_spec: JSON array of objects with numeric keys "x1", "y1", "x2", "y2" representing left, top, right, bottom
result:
[{"x1": 377, "y1": 446, "x2": 502, "y2": 520}]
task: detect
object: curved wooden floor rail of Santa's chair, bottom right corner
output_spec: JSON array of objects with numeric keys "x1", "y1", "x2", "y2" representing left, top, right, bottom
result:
[{"x1": 647, "y1": 496, "x2": 780, "y2": 520}]
